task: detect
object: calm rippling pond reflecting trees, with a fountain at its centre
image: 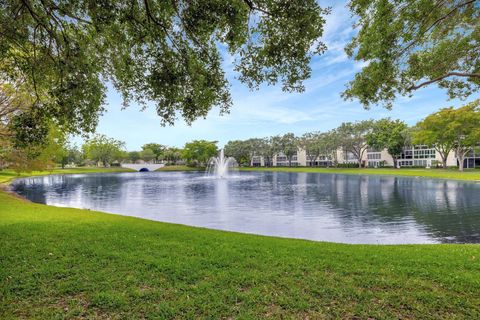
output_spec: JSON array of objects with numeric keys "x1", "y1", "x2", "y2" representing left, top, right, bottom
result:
[{"x1": 13, "y1": 172, "x2": 480, "y2": 244}]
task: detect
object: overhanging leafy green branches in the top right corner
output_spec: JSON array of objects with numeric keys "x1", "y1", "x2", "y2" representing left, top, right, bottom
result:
[{"x1": 343, "y1": 0, "x2": 480, "y2": 108}]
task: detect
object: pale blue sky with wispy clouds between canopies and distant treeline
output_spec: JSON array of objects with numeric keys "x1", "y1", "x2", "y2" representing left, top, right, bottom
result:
[{"x1": 88, "y1": 1, "x2": 473, "y2": 151}]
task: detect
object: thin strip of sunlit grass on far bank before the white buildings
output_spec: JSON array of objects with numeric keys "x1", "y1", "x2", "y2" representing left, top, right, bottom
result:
[{"x1": 241, "y1": 167, "x2": 480, "y2": 181}]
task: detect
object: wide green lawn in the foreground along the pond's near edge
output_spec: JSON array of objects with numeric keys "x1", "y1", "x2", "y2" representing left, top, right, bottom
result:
[{"x1": 0, "y1": 168, "x2": 480, "y2": 319}]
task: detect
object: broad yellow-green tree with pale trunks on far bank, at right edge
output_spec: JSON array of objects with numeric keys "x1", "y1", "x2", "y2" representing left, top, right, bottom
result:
[{"x1": 413, "y1": 100, "x2": 480, "y2": 171}]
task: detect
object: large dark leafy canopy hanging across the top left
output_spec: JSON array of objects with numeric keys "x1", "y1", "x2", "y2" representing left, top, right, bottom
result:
[{"x1": 0, "y1": 0, "x2": 328, "y2": 132}]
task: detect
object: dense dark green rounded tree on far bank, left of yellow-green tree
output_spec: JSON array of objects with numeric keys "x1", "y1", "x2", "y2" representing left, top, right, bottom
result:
[{"x1": 366, "y1": 118, "x2": 410, "y2": 168}]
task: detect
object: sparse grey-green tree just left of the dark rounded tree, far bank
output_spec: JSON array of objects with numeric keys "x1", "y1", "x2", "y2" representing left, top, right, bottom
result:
[{"x1": 337, "y1": 120, "x2": 373, "y2": 168}]
